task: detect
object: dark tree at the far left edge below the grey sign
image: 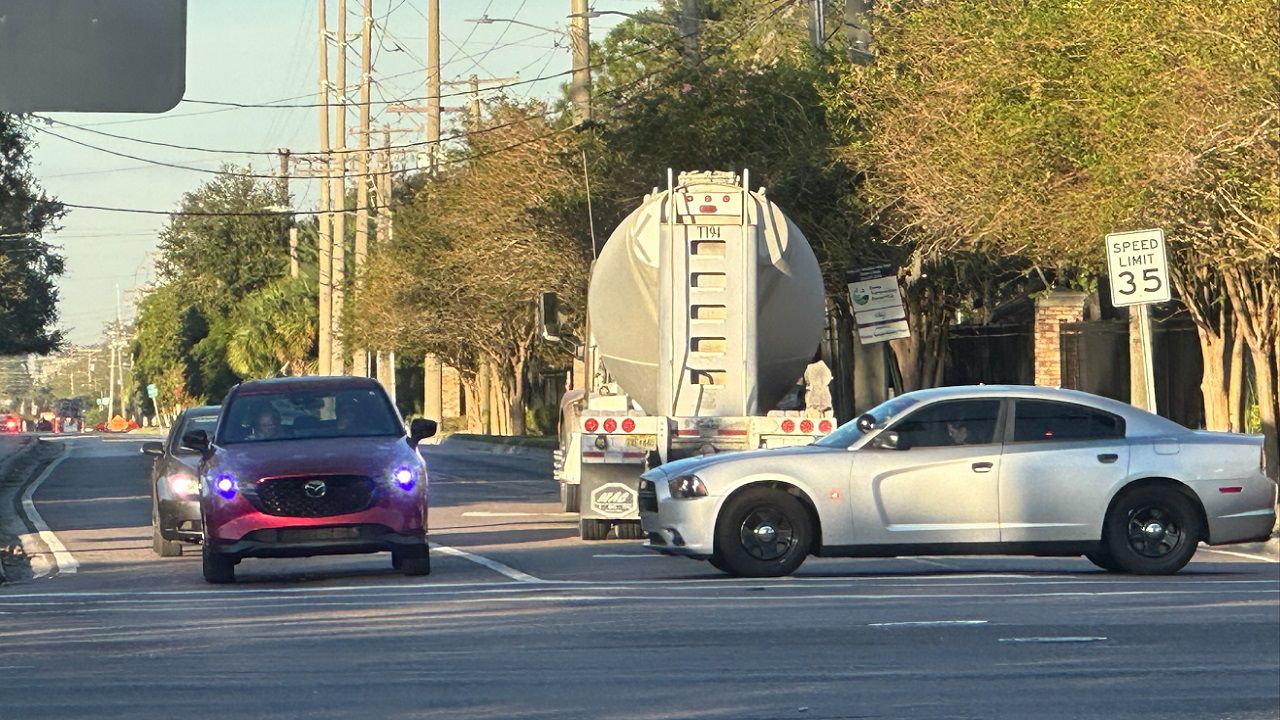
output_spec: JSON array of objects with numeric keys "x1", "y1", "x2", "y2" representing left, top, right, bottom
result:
[{"x1": 0, "y1": 113, "x2": 64, "y2": 355}]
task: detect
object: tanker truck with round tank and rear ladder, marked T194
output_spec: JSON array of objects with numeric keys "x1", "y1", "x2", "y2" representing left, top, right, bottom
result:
[{"x1": 556, "y1": 170, "x2": 835, "y2": 539}]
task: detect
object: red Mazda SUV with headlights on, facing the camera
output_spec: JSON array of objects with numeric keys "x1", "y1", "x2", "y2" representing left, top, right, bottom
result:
[{"x1": 182, "y1": 377, "x2": 436, "y2": 583}]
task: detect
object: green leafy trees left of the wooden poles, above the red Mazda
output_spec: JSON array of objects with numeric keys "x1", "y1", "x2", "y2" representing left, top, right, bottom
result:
[{"x1": 133, "y1": 165, "x2": 309, "y2": 405}]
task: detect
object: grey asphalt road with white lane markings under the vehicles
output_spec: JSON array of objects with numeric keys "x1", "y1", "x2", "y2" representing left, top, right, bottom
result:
[{"x1": 0, "y1": 430, "x2": 1280, "y2": 720}]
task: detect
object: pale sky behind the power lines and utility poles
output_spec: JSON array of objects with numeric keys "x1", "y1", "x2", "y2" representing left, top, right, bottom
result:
[{"x1": 32, "y1": 0, "x2": 640, "y2": 345}]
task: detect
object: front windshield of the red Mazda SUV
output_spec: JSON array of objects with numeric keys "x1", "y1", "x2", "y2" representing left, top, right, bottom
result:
[{"x1": 218, "y1": 388, "x2": 404, "y2": 445}]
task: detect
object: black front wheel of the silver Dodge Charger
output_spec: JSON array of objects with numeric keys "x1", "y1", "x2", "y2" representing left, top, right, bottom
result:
[{"x1": 716, "y1": 488, "x2": 813, "y2": 578}]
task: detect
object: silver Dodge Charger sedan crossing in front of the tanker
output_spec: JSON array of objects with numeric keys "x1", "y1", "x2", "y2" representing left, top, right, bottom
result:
[{"x1": 639, "y1": 386, "x2": 1276, "y2": 577}]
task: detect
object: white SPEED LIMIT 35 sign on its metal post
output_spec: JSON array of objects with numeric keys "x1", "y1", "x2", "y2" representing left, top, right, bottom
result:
[{"x1": 1106, "y1": 228, "x2": 1172, "y2": 413}]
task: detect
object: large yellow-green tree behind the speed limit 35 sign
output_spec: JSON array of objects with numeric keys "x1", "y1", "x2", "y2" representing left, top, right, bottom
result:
[{"x1": 828, "y1": 0, "x2": 1280, "y2": 466}]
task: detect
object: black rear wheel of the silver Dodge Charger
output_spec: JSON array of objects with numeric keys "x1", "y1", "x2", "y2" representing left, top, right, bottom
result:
[{"x1": 1102, "y1": 486, "x2": 1204, "y2": 575}]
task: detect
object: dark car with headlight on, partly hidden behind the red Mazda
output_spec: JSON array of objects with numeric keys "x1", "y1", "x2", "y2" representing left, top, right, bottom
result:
[{"x1": 142, "y1": 405, "x2": 220, "y2": 557}]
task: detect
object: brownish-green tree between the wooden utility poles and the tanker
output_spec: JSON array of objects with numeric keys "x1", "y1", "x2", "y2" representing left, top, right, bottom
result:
[{"x1": 347, "y1": 104, "x2": 590, "y2": 434}]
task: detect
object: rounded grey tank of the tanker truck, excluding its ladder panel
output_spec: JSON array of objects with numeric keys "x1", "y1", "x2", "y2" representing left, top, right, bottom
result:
[{"x1": 588, "y1": 176, "x2": 826, "y2": 415}]
